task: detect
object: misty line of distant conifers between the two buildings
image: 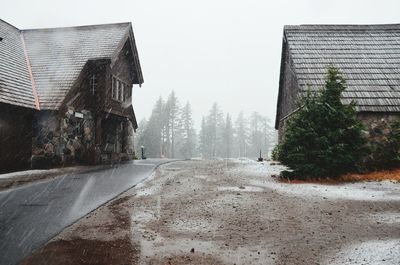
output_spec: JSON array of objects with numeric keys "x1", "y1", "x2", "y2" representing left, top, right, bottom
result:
[{"x1": 135, "y1": 92, "x2": 277, "y2": 158}]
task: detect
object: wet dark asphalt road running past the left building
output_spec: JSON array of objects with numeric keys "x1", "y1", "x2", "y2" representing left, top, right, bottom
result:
[{"x1": 0, "y1": 159, "x2": 166, "y2": 265}]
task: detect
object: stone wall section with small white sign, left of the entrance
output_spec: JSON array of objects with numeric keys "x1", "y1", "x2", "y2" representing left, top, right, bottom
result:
[{"x1": 32, "y1": 107, "x2": 95, "y2": 168}]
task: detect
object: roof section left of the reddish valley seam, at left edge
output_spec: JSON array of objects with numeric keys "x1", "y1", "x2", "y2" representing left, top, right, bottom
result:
[{"x1": 0, "y1": 19, "x2": 36, "y2": 108}]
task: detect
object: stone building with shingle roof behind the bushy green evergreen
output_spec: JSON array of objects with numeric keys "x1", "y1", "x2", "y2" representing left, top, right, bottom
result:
[{"x1": 275, "y1": 24, "x2": 400, "y2": 140}]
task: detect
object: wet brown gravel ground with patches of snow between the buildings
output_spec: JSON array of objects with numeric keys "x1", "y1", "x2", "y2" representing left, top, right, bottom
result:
[{"x1": 22, "y1": 160, "x2": 400, "y2": 265}]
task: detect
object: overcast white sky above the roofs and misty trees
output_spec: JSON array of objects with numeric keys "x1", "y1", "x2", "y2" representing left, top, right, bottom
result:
[{"x1": 0, "y1": 0, "x2": 400, "y2": 125}]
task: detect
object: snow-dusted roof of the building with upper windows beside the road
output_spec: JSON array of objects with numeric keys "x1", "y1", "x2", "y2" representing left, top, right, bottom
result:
[{"x1": 0, "y1": 20, "x2": 143, "y2": 110}]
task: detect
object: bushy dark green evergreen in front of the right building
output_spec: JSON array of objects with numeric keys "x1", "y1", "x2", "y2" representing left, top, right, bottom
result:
[{"x1": 279, "y1": 66, "x2": 366, "y2": 178}]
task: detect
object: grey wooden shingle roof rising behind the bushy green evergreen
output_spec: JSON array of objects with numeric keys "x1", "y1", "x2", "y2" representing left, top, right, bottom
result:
[{"x1": 284, "y1": 24, "x2": 400, "y2": 112}]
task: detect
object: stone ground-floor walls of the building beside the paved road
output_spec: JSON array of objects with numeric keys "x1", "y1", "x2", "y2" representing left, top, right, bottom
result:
[{"x1": 32, "y1": 108, "x2": 135, "y2": 168}]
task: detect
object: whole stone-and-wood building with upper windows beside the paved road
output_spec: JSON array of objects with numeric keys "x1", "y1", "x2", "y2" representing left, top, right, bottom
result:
[{"x1": 0, "y1": 20, "x2": 143, "y2": 171}]
